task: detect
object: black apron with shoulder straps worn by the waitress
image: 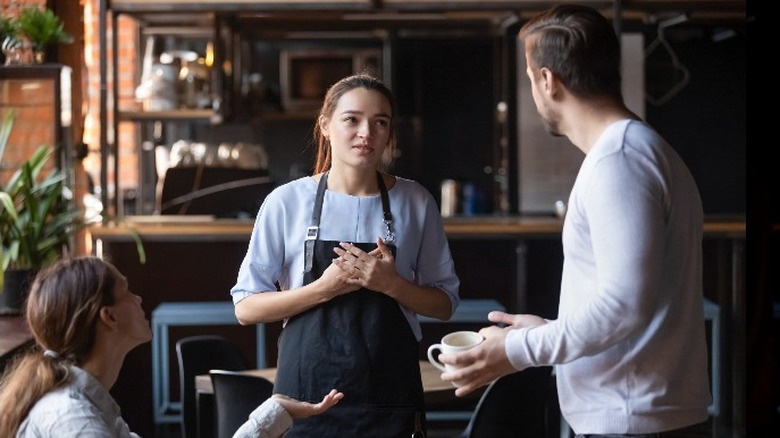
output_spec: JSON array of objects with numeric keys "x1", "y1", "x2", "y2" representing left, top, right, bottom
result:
[{"x1": 274, "y1": 172, "x2": 425, "y2": 438}]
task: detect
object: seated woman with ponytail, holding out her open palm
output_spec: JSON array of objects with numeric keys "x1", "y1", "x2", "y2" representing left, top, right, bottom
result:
[{"x1": 0, "y1": 256, "x2": 343, "y2": 438}]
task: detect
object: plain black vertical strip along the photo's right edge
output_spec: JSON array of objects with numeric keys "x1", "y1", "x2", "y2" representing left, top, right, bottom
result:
[{"x1": 745, "y1": 1, "x2": 780, "y2": 436}]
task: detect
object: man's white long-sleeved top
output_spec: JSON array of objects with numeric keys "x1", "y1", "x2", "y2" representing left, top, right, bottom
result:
[{"x1": 506, "y1": 120, "x2": 711, "y2": 434}]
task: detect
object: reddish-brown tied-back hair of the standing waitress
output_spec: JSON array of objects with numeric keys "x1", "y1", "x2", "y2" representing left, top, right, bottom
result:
[{"x1": 314, "y1": 73, "x2": 396, "y2": 174}]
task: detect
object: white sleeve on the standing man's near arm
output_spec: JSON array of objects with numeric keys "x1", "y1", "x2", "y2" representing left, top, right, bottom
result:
[{"x1": 506, "y1": 133, "x2": 665, "y2": 369}]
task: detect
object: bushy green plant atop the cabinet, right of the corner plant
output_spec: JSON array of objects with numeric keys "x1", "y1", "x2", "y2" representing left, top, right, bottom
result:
[{"x1": 17, "y1": 6, "x2": 73, "y2": 63}]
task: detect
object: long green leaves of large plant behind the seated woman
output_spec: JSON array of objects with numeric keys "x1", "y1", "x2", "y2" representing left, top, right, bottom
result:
[{"x1": 0, "y1": 112, "x2": 86, "y2": 313}]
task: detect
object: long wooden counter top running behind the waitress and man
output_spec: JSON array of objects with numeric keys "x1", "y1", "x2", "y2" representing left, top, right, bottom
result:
[{"x1": 90, "y1": 216, "x2": 745, "y2": 241}]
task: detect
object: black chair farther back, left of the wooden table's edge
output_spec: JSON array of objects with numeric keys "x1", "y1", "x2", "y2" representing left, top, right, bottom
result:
[{"x1": 176, "y1": 335, "x2": 251, "y2": 438}]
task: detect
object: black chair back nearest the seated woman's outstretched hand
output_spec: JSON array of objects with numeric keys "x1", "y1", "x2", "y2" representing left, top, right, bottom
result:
[{"x1": 209, "y1": 370, "x2": 274, "y2": 438}]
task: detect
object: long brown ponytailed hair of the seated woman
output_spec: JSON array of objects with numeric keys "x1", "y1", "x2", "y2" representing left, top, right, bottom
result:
[{"x1": 0, "y1": 256, "x2": 119, "y2": 437}]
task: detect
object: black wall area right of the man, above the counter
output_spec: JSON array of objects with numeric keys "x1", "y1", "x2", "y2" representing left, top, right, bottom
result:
[{"x1": 646, "y1": 27, "x2": 747, "y2": 214}]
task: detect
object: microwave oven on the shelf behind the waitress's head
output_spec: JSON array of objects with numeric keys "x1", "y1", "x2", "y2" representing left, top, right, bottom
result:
[{"x1": 279, "y1": 48, "x2": 382, "y2": 111}]
